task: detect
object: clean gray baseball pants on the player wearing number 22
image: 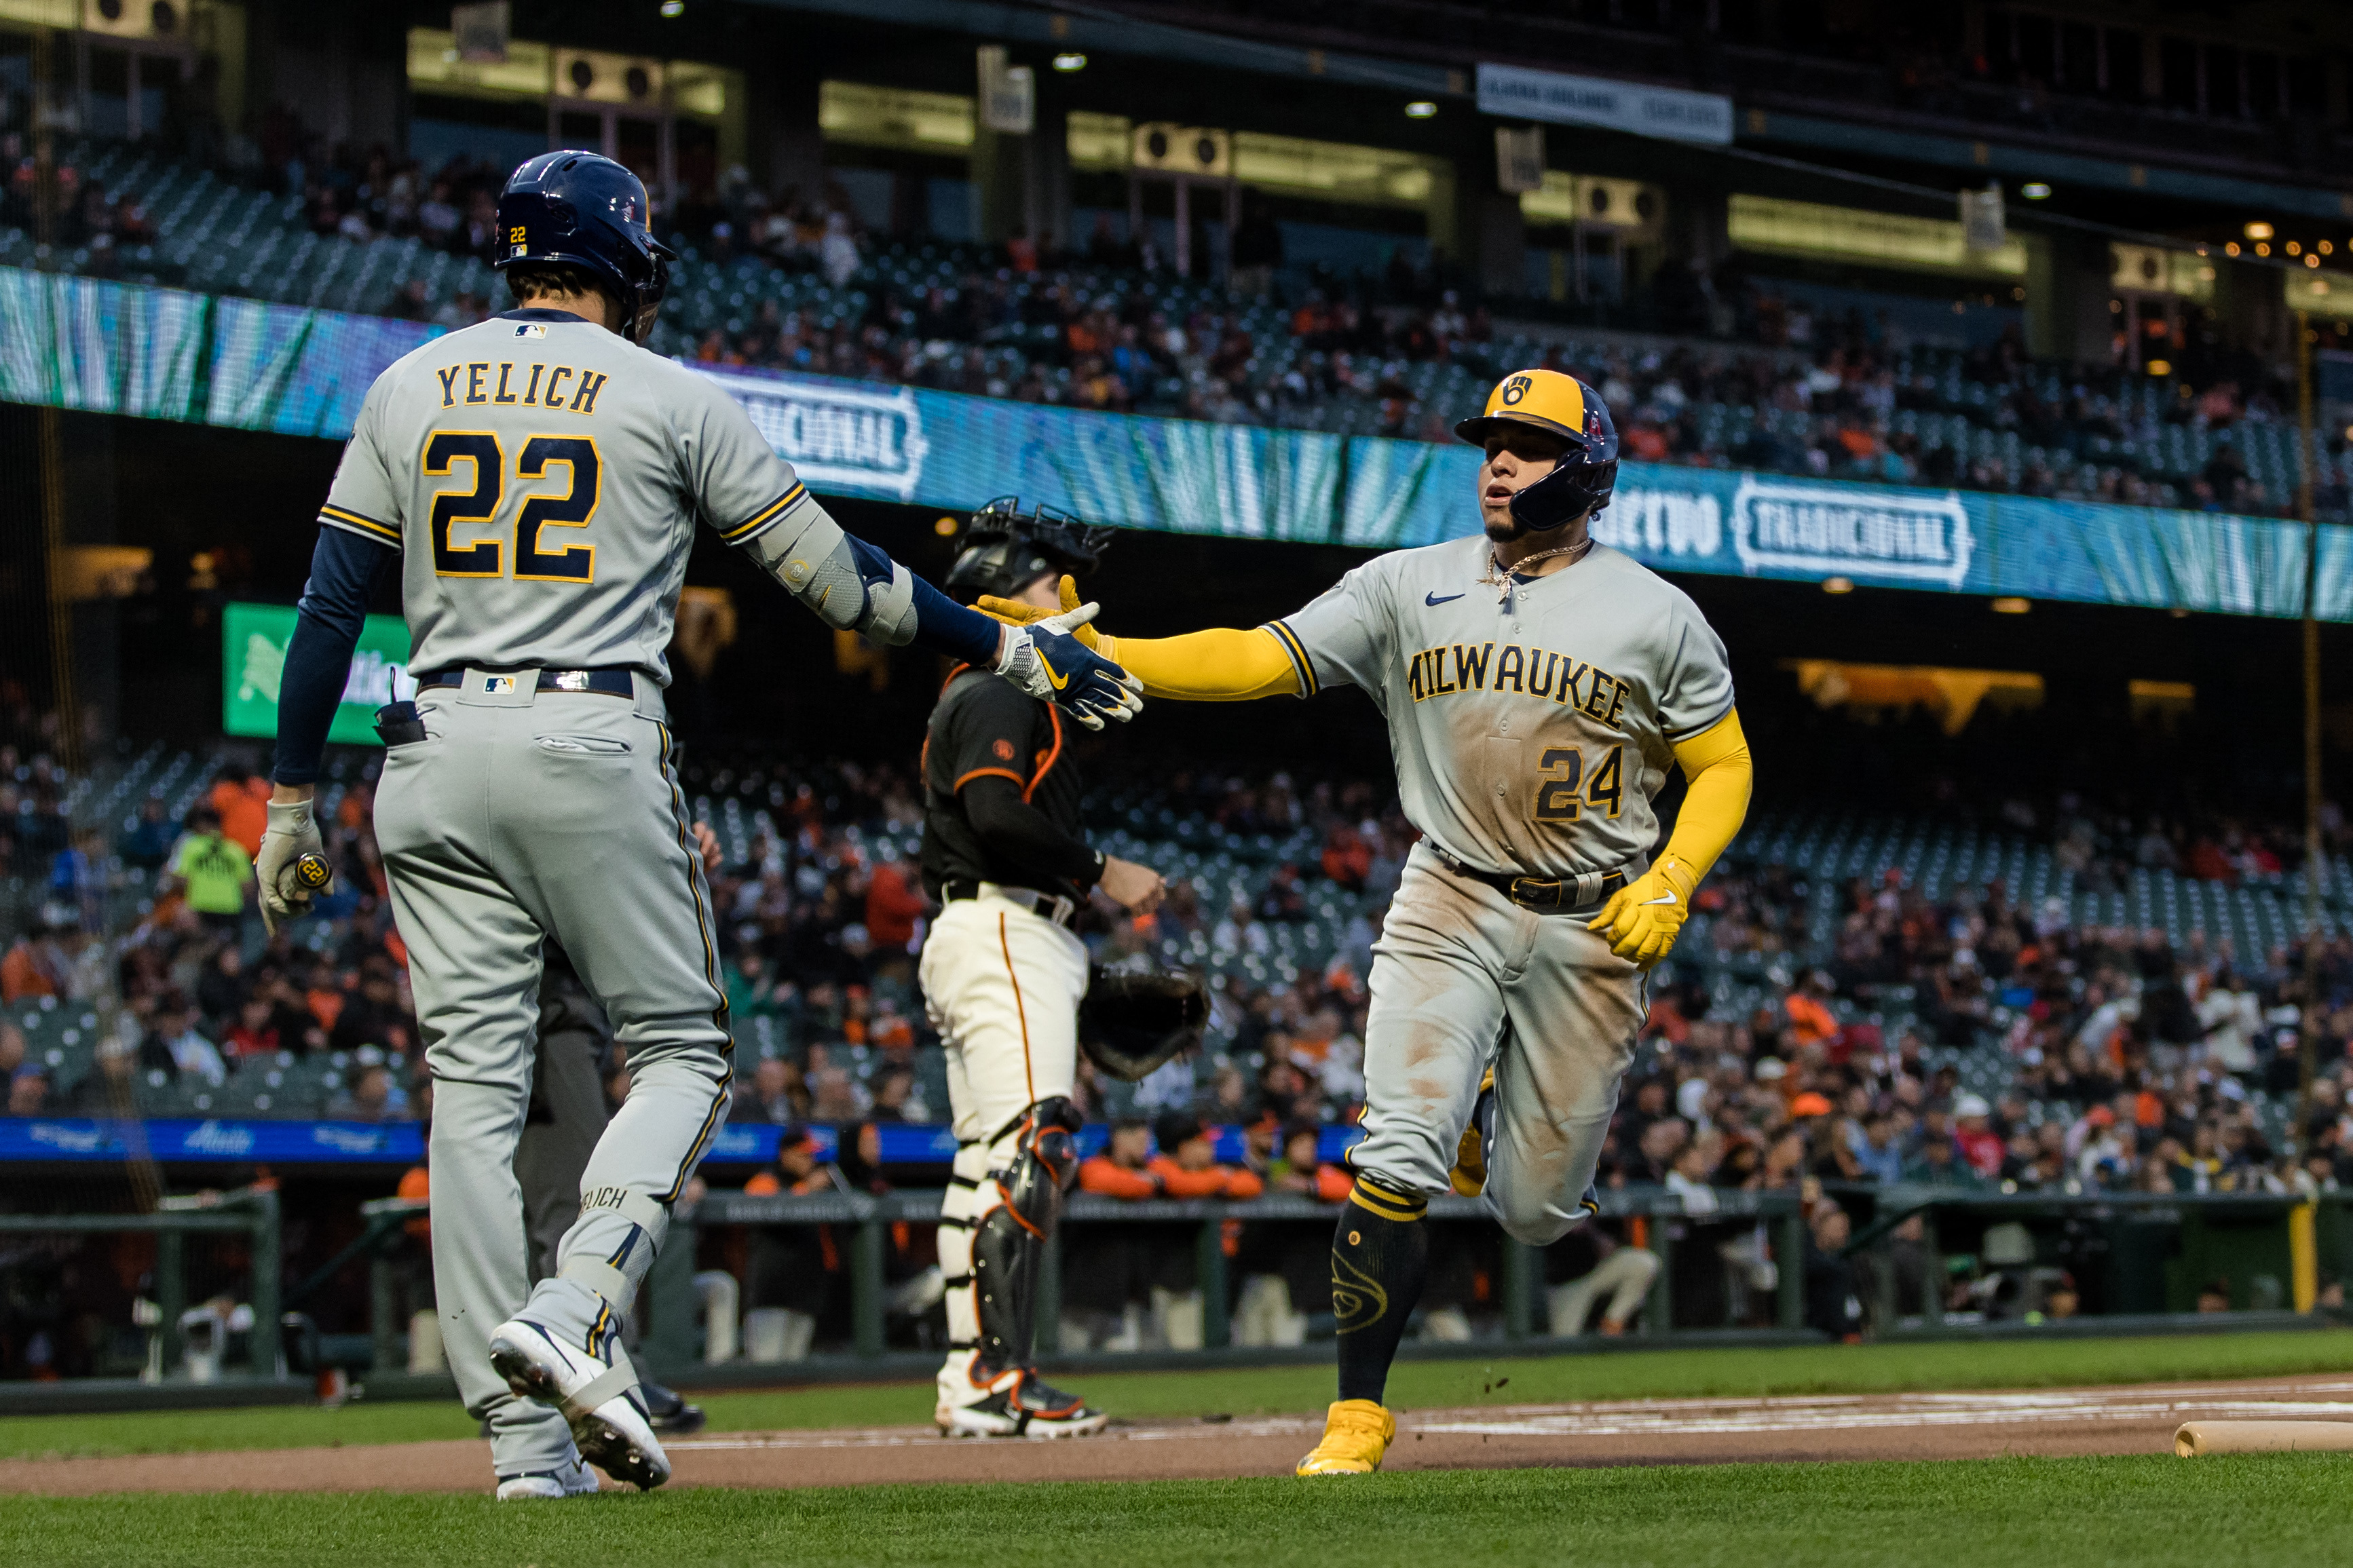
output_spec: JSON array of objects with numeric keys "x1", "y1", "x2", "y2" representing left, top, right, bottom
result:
[{"x1": 377, "y1": 670, "x2": 732, "y2": 1474}]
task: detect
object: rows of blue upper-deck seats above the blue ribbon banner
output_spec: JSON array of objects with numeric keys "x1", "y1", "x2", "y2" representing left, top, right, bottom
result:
[{"x1": 0, "y1": 141, "x2": 2353, "y2": 527}]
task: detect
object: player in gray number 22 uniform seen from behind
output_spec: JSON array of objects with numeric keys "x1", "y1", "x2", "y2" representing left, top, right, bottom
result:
[{"x1": 257, "y1": 153, "x2": 1137, "y2": 1497}]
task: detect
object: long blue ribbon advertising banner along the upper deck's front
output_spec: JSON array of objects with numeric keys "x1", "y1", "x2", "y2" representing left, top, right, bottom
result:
[{"x1": 0, "y1": 268, "x2": 2353, "y2": 621}]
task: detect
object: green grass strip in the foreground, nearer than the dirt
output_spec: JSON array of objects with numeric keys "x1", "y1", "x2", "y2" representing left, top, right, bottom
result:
[{"x1": 0, "y1": 1455, "x2": 2353, "y2": 1568}]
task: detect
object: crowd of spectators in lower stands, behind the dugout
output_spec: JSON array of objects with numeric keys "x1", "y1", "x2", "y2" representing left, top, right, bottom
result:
[{"x1": 14, "y1": 681, "x2": 2353, "y2": 1222}]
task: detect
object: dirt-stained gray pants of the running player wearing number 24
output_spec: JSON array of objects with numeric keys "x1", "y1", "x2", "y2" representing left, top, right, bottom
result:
[{"x1": 1349, "y1": 844, "x2": 1647, "y2": 1246}]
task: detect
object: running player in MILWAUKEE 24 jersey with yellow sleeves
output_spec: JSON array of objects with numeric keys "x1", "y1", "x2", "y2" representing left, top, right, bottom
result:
[{"x1": 981, "y1": 369, "x2": 1750, "y2": 1476}]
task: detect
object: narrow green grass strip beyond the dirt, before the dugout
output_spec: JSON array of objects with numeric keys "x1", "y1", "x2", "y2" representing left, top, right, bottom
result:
[{"x1": 0, "y1": 1331, "x2": 2353, "y2": 1460}]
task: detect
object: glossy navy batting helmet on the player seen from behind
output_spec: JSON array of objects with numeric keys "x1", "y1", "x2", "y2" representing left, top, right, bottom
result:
[{"x1": 492, "y1": 153, "x2": 675, "y2": 343}]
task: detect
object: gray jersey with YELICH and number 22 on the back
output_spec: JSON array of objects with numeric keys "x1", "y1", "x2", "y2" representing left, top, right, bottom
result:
[{"x1": 320, "y1": 310, "x2": 814, "y2": 684}]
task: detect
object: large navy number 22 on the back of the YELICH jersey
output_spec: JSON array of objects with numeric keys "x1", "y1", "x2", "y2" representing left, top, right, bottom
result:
[{"x1": 423, "y1": 430, "x2": 605, "y2": 583}]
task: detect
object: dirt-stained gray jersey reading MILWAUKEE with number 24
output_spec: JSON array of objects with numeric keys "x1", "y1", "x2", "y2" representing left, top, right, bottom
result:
[{"x1": 1268, "y1": 538, "x2": 1732, "y2": 877}]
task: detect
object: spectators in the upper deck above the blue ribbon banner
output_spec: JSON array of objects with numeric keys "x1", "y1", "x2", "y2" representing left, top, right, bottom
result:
[{"x1": 0, "y1": 111, "x2": 2353, "y2": 531}]
